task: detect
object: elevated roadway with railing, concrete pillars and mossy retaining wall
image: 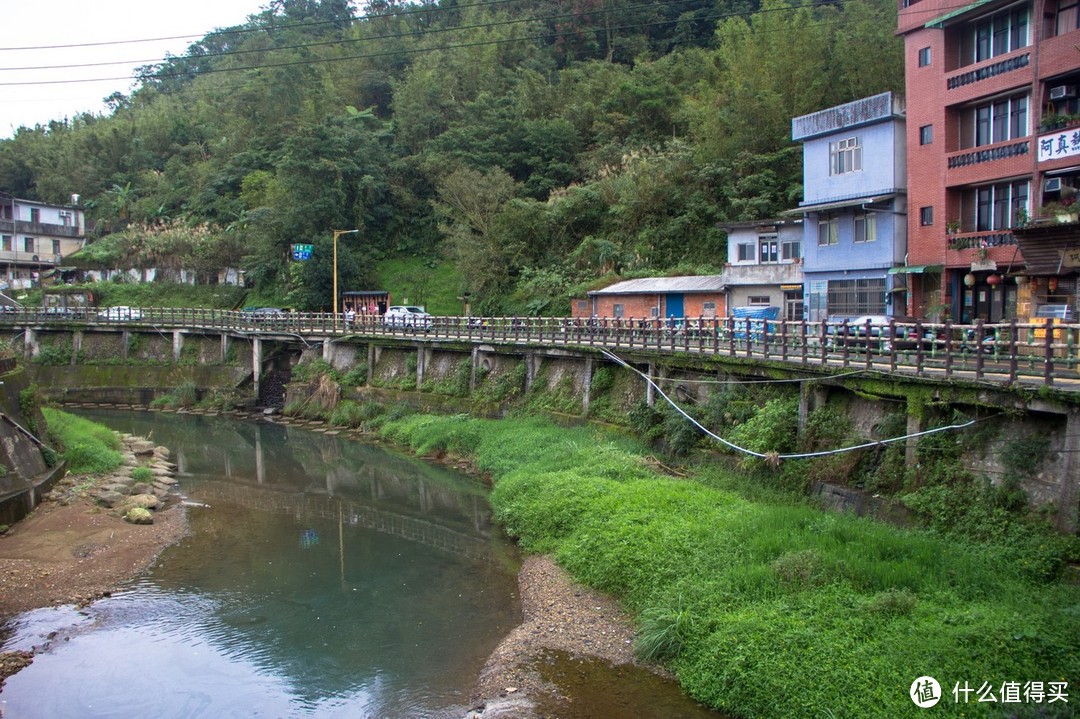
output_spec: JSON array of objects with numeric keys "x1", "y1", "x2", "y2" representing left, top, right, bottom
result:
[{"x1": 0, "y1": 308, "x2": 1080, "y2": 530}]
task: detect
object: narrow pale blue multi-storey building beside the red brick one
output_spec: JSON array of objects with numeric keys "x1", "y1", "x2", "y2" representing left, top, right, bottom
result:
[{"x1": 791, "y1": 93, "x2": 907, "y2": 322}]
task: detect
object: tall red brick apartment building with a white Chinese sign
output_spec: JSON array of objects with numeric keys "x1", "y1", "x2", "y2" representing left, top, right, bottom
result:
[{"x1": 897, "y1": 0, "x2": 1080, "y2": 322}]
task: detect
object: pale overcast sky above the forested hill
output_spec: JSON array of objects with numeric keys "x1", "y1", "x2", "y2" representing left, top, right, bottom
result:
[{"x1": 0, "y1": 0, "x2": 267, "y2": 139}]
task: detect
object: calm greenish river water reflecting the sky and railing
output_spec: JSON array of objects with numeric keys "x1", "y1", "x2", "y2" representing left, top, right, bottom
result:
[{"x1": 0, "y1": 410, "x2": 716, "y2": 719}]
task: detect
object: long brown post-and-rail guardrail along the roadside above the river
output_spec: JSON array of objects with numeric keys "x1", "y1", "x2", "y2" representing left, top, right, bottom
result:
[{"x1": 6, "y1": 308, "x2": 1080, "y2": 391}]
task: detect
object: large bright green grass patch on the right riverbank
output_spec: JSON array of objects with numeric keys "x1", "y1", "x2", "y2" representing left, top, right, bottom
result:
[{"x1": 383, "y1": 416, "x2": 1080, "y2": 719}]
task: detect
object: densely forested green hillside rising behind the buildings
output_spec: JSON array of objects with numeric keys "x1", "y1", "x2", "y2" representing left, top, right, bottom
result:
[{"x1": 0, "y1": 0, "x2": 903, "y2": 314}]
